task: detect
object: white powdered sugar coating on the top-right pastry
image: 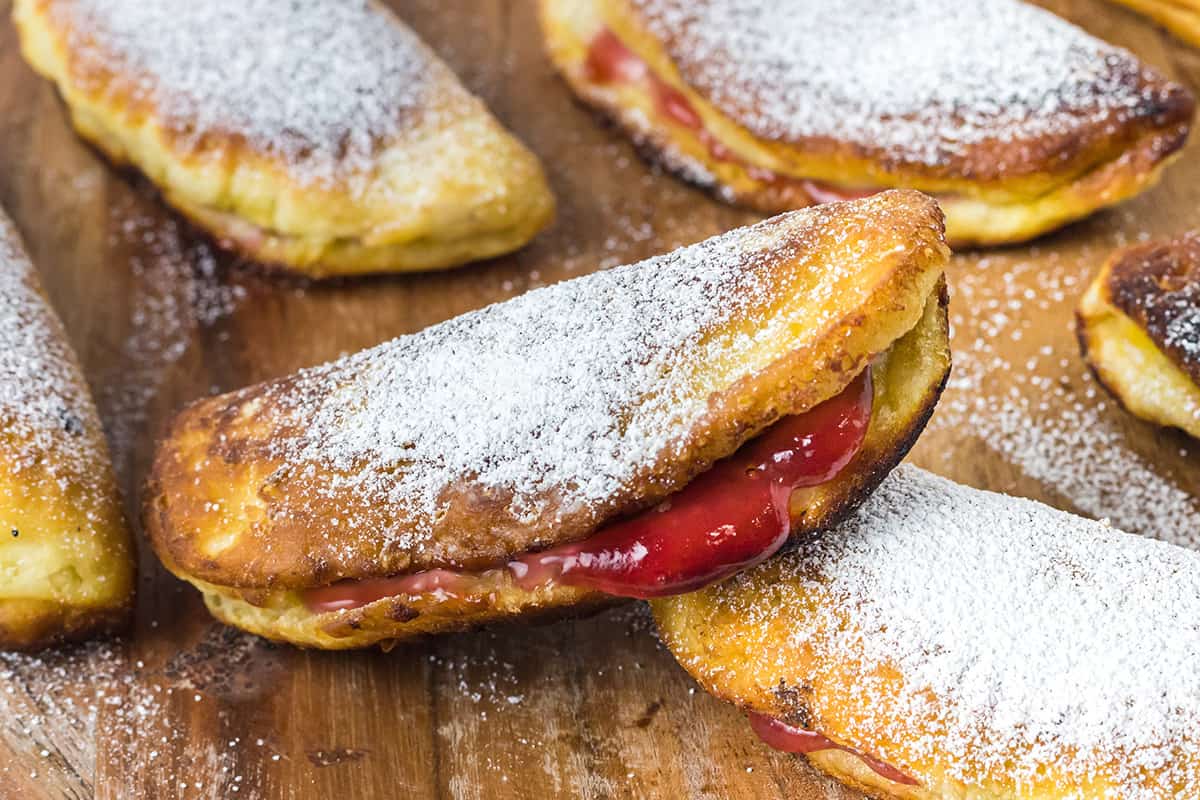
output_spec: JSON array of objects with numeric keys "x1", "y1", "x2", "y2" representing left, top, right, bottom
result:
[{"x1": 634, "y1": 0, "x2": 1159, "y2": 164}]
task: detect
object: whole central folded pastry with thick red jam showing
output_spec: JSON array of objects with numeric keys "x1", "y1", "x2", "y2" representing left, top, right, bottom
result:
[{"x1": 145, "y1": 192, "x2": 949, "y2": 648}]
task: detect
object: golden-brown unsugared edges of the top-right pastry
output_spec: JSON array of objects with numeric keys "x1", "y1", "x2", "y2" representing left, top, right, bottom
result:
[{"x1": 540, "y1": 0, "x2": 1194, "y2": 247}]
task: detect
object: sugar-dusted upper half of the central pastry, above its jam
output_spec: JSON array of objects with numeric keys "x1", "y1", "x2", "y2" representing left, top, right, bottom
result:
[{"x1": 150, "y1": 192, "x2": 947, "y2": 585}]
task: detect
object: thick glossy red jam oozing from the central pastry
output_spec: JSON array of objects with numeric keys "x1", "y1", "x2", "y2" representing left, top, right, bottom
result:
[{"x1": 304, "y1": 371, "x2": 872, "y2": 613}]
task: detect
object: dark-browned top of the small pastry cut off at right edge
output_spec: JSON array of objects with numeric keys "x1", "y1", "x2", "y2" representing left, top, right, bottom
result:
[{"x1": 1106, "y1": 233, "x2": 1200, "y2": 384}]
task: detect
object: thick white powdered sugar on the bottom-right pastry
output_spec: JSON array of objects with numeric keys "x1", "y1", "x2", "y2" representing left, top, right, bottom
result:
[{"x1": 768, "y1": 467, "x2": 1200, "y2": 800}]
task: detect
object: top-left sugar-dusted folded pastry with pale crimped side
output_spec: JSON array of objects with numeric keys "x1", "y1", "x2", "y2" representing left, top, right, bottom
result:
[{"x1": 13, "y1": 0, "x2": 554, "y2": 277}]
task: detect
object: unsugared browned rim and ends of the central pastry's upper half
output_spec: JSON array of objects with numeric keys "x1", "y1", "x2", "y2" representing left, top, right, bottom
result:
[{"x1": 145, "y1": 192, "x2": 947, "y2": 589}]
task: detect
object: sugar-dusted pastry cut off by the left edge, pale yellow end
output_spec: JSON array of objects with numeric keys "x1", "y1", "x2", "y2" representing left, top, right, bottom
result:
[{"x1": 0, "y1": 211, "x2": 134, "y2": 649}]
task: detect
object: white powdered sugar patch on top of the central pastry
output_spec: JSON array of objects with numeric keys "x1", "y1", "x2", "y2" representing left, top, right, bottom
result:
[{"x1": 268, "y1": 199, "x2": 889, "y2": 545}]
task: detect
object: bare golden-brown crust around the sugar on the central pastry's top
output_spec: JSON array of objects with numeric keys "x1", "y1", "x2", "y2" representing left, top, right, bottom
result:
[{"x1": 145, "y1": 192, "x2": 947, "y2": 588}]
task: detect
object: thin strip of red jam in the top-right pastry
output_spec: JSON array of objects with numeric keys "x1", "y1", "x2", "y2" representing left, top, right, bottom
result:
[{"x1": 583, "y1": 28, "x2": 880, "y2": 203}]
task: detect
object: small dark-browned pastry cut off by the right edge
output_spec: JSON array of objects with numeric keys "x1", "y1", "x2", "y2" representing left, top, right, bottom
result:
[{"x1": 1075, "y1": 234, "x2": 1200, "y2": 438}]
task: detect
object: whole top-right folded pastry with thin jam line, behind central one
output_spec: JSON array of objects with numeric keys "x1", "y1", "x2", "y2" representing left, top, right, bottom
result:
[{"x1": 541, "y1": 0, "x2": 1194, "y2": 245}]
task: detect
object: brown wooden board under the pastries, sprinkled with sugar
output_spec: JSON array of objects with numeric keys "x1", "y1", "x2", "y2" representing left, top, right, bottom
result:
[{"x1": 0, "y1": 0, "x2": 1200, "y2": 800}]
